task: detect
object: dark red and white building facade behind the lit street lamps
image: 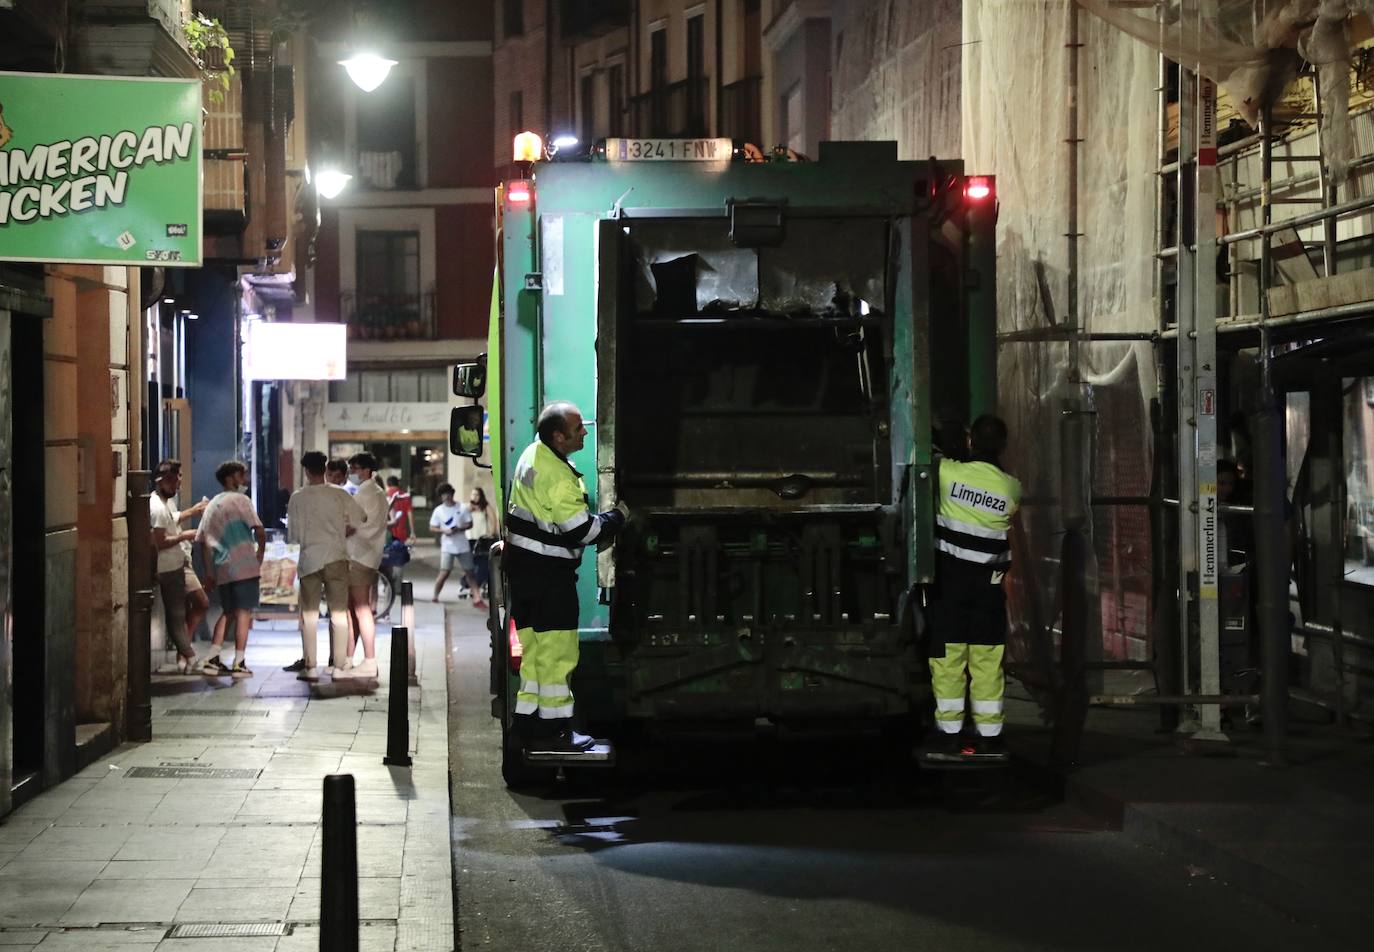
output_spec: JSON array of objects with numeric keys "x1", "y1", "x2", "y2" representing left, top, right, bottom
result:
[{"x1": 292, "y1": 0, "x2": 495, "y2": 533}]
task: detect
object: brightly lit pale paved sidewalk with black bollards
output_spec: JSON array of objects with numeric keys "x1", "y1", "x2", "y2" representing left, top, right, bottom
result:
[{"x1": 0, "y1": 578, "x2": 453, "y2": 952}]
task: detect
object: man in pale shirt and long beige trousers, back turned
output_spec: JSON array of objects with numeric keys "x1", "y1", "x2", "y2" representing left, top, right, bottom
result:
[{"x1": 286, "y1": 451, "x2": 367, "y2": 681}]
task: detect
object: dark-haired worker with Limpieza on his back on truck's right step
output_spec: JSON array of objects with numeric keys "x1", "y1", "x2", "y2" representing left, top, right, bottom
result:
[{"x1": 929, "y1": 415, "x2": 1021, "y2": 756}]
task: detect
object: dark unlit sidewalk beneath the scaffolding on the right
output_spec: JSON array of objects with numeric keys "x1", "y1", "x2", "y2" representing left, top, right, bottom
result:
[{"x1": 1009, "y1": 695, "x2": 1374, "y2": 945}]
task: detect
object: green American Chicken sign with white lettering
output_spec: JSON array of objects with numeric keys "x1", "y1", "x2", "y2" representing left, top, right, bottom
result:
[{"x1": 0, "y1": 71, "x2": 201, "y2": 268}]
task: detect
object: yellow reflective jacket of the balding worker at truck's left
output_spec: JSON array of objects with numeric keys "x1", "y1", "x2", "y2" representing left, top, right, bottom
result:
[{"x1": 506, "y1": 440, "x2": 602, "y2": 560}]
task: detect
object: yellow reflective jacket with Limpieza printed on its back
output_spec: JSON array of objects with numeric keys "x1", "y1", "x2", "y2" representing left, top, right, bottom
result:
[{"x1": 936, "y1": 459, "x2": 1021, "y2": 571}]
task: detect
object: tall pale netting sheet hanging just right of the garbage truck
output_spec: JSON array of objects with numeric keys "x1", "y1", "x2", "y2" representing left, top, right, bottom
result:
[{"x1": 962, "y1": 0, "x2": 1160, "y2": 673}]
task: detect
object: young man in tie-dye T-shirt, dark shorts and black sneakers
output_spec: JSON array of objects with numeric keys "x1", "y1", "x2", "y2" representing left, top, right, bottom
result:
[{"x1": 195, "y1": 459, "x2": 267, "y2": 677}]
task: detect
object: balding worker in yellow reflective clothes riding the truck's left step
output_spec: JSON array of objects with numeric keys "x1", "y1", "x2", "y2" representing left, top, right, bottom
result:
[{"x1": 504, "y1": 403, "x2": 628, "y2": 753}]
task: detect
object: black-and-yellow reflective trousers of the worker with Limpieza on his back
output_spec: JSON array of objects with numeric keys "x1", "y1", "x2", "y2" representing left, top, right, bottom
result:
[{"x1": 927, "y1": 554, "x2": 1007, "y2": 738}]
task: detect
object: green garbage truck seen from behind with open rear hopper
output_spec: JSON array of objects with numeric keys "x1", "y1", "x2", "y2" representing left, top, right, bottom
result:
[{"x1": 451, "y1": 139, "x2": 996, "y2": 782}]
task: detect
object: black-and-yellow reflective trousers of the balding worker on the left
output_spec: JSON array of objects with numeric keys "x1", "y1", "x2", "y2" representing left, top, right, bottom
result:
[{"x1": 506, "y1": 549, "x2": 578, "y2": 727}]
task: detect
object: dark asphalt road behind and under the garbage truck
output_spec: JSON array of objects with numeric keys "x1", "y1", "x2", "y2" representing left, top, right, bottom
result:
[{"x1": 449, "y1": 606, "x2": 1338, "y2": 952}]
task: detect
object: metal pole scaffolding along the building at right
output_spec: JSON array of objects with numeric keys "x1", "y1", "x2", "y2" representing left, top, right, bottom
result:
[{"x1": 966, "y1": 0, "x2": 1374, "y2": 762}]
